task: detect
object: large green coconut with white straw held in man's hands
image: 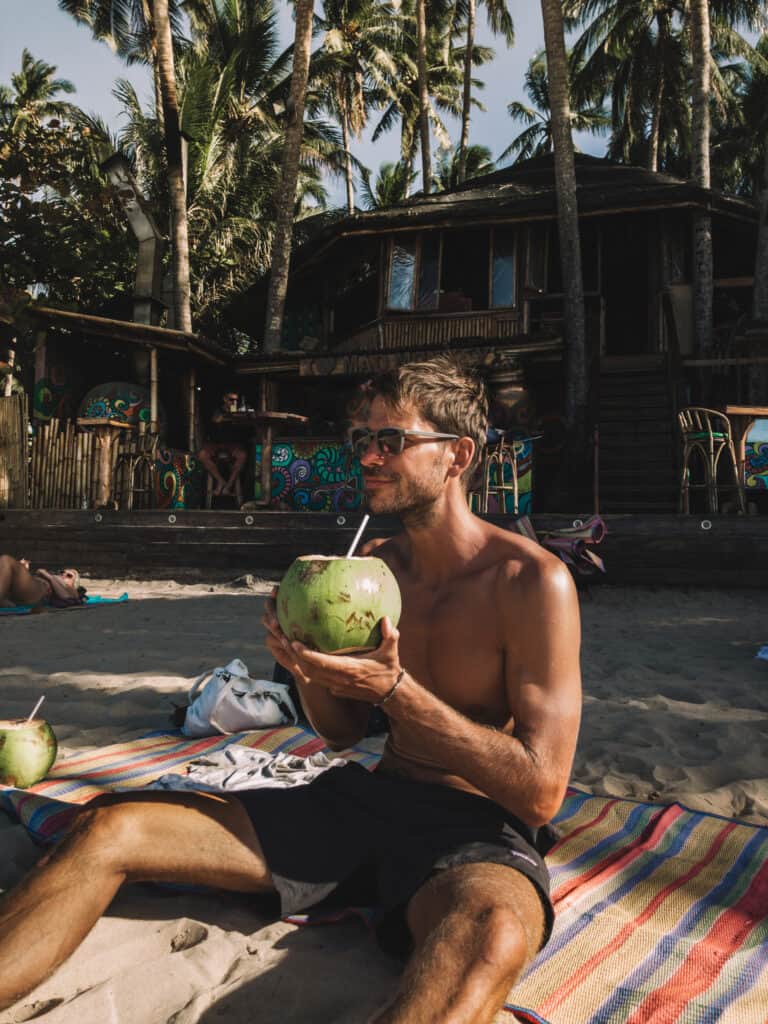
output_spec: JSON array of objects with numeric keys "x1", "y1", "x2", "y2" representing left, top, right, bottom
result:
[{"x1": 278, "y1": 555, "x2": 401, "y2": 654}]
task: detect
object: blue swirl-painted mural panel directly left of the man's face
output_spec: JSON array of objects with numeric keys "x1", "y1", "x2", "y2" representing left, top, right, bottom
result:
[{"x1": 253, "y1": 437, "x2": 362, "y2": 512}]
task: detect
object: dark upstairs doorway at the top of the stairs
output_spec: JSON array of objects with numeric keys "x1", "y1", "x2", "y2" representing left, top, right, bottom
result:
[{"x1": 602, "y1": 215, "x2": 652, "y2": 355}]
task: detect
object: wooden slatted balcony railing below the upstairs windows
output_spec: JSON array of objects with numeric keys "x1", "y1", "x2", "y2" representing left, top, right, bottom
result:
[{"x1": 334, "y1": 310, "x2": 522, "y2": 351}]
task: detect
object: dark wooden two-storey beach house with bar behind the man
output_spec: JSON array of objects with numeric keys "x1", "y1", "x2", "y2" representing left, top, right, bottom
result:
[{"x1": 0, "y1": 156, "x2": 768, "y2": 584}]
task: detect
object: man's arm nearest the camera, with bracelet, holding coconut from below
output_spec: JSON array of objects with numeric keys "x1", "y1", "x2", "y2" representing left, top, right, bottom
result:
[{"x1": 288, "y1": 558, "x2": 582, "y2": 827}]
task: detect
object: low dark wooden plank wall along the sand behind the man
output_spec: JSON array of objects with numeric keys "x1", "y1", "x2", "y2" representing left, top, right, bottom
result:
[{"x1": 0, "y1": 510, "x2": 768, "y2": 587}]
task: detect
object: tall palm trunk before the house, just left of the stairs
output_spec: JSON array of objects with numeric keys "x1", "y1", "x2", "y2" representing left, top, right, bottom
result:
[{"x1": 542, "y1": 0, "x2": 587, "y2": 448}]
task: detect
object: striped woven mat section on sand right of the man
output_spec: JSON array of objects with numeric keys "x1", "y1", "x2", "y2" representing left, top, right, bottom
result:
[{"x1": 514, "y1": 791, "x2": 768, "y2": 1024}]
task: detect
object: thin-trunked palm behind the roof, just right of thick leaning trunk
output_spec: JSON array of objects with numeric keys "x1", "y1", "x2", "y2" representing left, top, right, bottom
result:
[{"x1": 313, "y1": 0, "x2": 402, "y2": 213}]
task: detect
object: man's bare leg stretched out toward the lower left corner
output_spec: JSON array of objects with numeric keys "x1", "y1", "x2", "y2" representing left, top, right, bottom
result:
[{"x1": 0, "y1": 793, "x2": 272, "y2": 1010}]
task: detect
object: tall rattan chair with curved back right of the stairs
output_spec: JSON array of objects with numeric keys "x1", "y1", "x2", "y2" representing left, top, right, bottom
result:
[{"x1": 677, "y1": 406, "x2": 746, "y2": 514}]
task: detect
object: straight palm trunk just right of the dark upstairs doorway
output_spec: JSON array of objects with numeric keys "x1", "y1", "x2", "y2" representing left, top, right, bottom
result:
[{"x1": 690, "y1": 0, "x2": 713, "y2": 354}]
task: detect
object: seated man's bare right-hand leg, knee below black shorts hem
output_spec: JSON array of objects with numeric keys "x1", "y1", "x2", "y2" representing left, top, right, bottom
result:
[{"x1": 374, "y1": 864, "x2": 545, "y2": 1024}]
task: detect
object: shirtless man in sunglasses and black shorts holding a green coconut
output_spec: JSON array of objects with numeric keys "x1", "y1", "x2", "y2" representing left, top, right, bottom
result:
[{"x1": 0, "y1": 359, "x2": 581, "y2": 1024}]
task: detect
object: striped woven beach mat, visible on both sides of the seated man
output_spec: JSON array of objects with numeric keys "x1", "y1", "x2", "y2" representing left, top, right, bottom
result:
[{"x1": 0, "y1": 728, "x2": 768, "y2": 1024}]
